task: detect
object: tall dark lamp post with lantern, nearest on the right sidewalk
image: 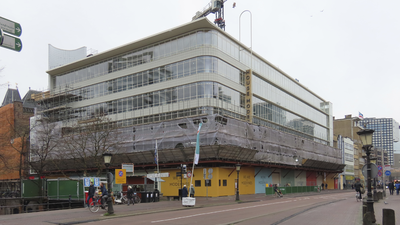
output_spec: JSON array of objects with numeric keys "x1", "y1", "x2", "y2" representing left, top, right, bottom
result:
[{"x1": 357, "y1": 129, "x2": 376, "y2": 223}]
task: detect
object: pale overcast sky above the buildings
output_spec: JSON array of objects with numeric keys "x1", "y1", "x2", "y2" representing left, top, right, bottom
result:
[{"x1": 0, "y1": 0, "x2": 400, "y2": 122}]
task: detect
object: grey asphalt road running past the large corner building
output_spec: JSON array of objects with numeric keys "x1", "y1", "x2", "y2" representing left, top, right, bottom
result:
[{"x1": 85, "y1": 192, "x2": 362, "y2": 225}]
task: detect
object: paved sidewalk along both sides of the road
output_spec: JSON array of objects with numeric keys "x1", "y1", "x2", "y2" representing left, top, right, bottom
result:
[{"x1": 0, "y1": 189, "x2": 400, "y2": 224}]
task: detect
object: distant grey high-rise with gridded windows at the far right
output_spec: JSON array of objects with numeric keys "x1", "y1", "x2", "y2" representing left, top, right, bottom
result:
[{"x1": 359, "y1": 118, "x2": 399, "y2": 165}]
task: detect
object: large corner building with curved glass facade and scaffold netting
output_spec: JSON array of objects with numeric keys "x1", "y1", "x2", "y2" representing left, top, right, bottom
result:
[{"x1": 35, "y1": 18, "x2": 344, "y2": 196}]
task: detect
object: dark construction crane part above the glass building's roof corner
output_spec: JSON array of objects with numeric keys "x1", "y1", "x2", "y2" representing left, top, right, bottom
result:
[{"x1": 192, "y1": 0, "x2": 227, "y2": 30}]
